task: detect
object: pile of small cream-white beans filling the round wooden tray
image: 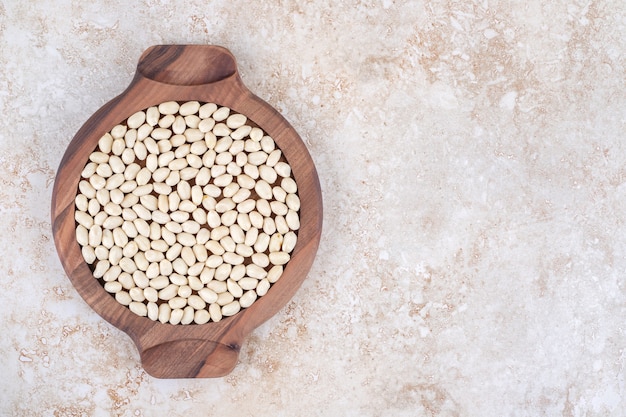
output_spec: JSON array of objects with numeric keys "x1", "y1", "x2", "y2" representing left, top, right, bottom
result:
[{"x1": 75, "y1": 101, "x2": 300, "y2": 324}]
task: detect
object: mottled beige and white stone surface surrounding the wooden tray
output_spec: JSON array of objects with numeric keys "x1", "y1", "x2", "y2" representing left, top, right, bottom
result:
[{"x1": 0, "y1": 0, "x2": 626, "y2": 417}]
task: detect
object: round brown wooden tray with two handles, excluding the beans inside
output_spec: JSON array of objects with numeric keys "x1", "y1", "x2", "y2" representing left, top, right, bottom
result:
[{"x1": 51, "y1": 45, "x2": 322, "y2": 378}]
